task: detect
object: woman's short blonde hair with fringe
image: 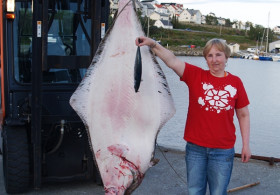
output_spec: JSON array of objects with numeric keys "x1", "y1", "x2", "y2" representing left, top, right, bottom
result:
[{"x1": 203, "y1": 38, "x2": 231, "y2": 59}]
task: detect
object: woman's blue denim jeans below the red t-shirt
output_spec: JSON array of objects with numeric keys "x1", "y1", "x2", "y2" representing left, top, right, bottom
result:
[{"x1": 186, "y1": 143, "x2": 234, "y2": 195}]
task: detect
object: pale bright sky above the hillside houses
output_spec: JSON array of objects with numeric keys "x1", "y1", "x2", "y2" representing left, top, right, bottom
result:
[{"x1": 157, "y1": 0, "x2": 280, "y2": 28}]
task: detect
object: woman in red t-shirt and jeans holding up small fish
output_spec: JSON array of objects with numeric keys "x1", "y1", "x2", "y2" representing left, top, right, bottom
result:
[{"x1": 135, "y1": 37, "x2": 251, "y2": 195}]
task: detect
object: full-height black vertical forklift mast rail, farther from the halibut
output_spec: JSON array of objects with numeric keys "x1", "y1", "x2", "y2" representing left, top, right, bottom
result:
[{"x1": 31, "y1": 0, "x2": 43, "y2": 189}]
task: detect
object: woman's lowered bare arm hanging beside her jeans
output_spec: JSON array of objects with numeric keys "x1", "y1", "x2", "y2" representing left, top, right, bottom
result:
[{"x1": 236, "y1": 106, "x2": 251, "y2": 162}]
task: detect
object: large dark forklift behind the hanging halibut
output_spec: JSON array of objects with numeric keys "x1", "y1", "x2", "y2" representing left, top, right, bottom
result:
[{"x1": 0, "y1": 0, "x2": 110, "y2": 194}]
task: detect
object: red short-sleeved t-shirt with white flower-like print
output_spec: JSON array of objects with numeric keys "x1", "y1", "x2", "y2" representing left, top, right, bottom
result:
[{"x1": 181, "y1": 63, "x2": 249, "y2": 149}]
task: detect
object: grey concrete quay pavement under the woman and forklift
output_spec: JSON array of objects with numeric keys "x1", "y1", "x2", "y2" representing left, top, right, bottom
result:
[{"x1": 0, "y1": 148, "x2": 280, "y2": 195}]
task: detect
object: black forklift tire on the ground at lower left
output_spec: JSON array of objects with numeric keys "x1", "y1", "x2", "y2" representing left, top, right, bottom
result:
[{"x1": 3, "y1": 126, "x2": 30, "y2": 194}]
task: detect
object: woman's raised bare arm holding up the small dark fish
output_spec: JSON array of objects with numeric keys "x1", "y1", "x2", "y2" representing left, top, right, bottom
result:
[{"x1": 135, "y1": 37, "x2": 185, "y2": 77}]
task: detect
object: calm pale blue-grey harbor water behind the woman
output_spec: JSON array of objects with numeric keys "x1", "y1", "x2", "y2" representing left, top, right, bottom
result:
[{"x1": 157, "y1": 56, "x2": 280, "y2": 158}]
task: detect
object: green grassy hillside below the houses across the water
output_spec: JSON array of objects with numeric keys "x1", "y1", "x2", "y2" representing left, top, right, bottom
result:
[{"x1": 150, "y1": 24, "x2": 274, "y2": 53}]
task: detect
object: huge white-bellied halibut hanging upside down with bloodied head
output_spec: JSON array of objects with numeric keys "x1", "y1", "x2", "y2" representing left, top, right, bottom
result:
[{"x1": 70, "y1": 0, "x2": 175, "y2": 195}]
